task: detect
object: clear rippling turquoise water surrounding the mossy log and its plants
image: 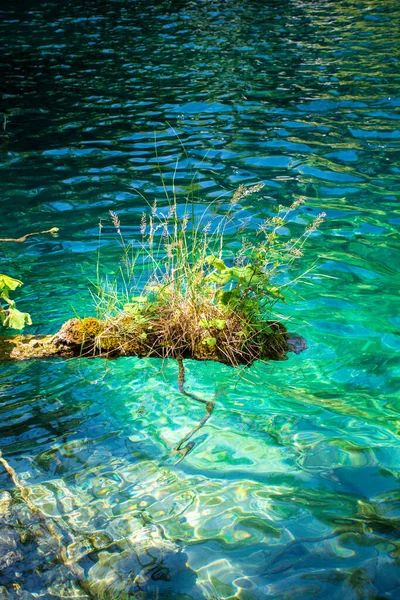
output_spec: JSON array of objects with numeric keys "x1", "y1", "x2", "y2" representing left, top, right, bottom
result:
[{"x1": 0, "y1": 0, "x2": 400, "y2": 600}]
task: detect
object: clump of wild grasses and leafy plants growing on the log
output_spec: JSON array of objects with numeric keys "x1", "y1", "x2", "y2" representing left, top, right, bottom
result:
[{"x1": 90, "y1": 178, "x2": 325, "y2": 366}]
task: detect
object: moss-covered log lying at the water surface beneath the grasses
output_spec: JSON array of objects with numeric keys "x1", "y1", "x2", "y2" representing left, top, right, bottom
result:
[{"x1": 0, "y1": 315, "x2": 307, "y2": 366}]
